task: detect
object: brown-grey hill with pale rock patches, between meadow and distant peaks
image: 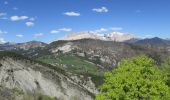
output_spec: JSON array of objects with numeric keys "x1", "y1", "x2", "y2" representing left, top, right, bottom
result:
[{"x1": 46, "y1": 39, "x2": 169, "y2": 68}]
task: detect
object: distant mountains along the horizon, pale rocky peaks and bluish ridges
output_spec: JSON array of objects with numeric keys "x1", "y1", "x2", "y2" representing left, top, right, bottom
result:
[{"x1": 0, "y1": 32, "x2": 170, "y2": 51}]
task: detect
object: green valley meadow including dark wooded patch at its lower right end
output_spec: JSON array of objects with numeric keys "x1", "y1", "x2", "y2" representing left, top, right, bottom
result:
[{"x1": 37, "y1": 54, "x2": 105, "y2": 86}]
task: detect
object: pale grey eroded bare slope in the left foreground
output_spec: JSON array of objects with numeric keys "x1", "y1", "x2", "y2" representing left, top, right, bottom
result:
[{"x1": 0, "y1": 58, "x2": 93, "y2": 100}]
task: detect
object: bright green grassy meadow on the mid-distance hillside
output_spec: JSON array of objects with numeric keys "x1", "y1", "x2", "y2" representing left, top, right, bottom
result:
[{"x1": 38, "y1": 54, "x2": 102, "y2": 75}]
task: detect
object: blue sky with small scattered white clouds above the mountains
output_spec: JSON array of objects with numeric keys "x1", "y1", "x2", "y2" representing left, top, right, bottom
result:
[{"x1": 0, "y1": 0, "x2": 170, "y2": 43}]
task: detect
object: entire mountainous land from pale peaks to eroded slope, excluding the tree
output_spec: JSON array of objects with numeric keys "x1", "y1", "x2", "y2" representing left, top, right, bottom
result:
[{"x1": 0, "y1": 32, "x2": 170, "y2": 100}]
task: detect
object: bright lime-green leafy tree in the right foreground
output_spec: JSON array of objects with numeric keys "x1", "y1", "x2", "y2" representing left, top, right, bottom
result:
[{"x1": 96, "y1": 55, "x2": 170, "y2": 100}]
